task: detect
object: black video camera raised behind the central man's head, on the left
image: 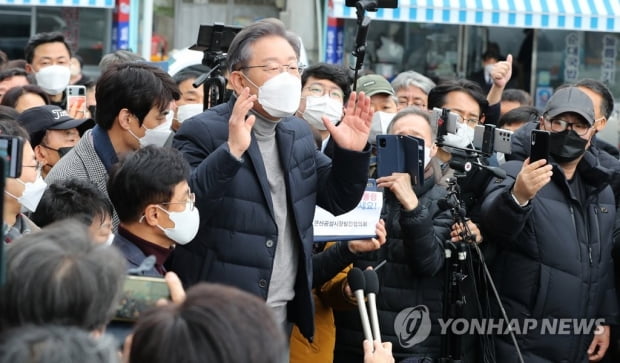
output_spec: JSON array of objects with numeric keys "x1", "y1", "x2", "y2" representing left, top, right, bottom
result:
[{"x1": 189, "y1": 23, "x2": 242, "y2": 110}]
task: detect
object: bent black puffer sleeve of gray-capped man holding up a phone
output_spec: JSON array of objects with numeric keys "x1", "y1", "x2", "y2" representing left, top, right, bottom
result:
[{"x1": 480, "y1": 161, "x2": 532, "y2": 241}]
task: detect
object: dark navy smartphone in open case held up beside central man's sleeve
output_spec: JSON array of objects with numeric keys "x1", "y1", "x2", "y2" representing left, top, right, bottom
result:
[{"x1": 377, "y1": 135, "x2": 424, "y2": 185}]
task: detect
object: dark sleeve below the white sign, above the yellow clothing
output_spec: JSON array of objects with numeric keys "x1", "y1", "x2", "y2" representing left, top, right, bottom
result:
[{"x1": 312, "y1": 241, "x2": 356, "y2": 288}]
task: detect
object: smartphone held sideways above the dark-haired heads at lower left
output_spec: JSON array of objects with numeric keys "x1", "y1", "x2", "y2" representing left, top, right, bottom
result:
[{"x1": 113, "y1": 276, "x2": 170, "y2": 322}]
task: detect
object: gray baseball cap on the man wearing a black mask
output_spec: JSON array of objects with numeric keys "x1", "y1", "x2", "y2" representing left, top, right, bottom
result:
[{"x1": 544, "y1": 87, "x2": 594, "y2": 125}]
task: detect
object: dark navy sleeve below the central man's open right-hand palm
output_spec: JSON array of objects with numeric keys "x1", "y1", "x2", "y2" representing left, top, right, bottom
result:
[{"x1": 316, "y1": 143, "x2": 370, "y2": 215}]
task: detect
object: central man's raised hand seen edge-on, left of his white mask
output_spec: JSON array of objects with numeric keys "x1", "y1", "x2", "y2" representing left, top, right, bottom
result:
[{"x1": 228, "y1": 87, "x2": 256, "y2": 159}]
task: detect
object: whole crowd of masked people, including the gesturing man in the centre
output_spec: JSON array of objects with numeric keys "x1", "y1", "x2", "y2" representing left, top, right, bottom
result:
[{"x1": 0, "y1": 19, "x2": 620, "y2": 363}]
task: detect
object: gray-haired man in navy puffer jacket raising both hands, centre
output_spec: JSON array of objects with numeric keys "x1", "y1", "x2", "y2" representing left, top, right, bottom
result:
[{"x1": 171, "y1": 19, "x2": 371, "y2": 339}]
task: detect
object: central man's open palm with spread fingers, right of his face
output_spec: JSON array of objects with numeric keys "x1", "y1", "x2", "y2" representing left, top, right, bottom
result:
[{"x1": 323, "y1": 92, "x2": 372, "y2": 151}]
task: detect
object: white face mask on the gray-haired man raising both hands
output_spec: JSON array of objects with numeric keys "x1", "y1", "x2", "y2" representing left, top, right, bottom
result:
[{"x1": 242, "y1": 72, "x2": 301, "y2": 118}]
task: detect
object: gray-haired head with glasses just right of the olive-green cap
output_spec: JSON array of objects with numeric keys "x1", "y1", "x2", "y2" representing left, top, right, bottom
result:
[{"x1": 392, "y1": 71, "x2": 435, "y2": 111}]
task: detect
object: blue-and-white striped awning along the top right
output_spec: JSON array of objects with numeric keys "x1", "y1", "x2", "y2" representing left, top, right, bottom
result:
[{"x1": 330, "y1": 0, "x2": 620, "y2": 33}]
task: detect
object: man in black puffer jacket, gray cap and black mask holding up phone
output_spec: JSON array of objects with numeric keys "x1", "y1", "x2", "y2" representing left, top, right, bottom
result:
[{"x1": 481, "y1": 87, "x2": 618, "y2": 363}]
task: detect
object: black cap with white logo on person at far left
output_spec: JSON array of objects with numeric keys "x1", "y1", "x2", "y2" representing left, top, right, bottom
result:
[{"x1": 17, "y1": 105, "x2": 94, "y2": 147}]
